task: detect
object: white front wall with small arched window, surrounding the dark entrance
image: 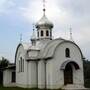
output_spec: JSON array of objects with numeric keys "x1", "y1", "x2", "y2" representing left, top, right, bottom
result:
[{"x1": 46, "y1": 43, "x2": 84, "y2": 89}]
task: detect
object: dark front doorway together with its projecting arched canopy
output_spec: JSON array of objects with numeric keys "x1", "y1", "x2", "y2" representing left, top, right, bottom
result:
[{"x1": 60, "y1": 60, "x2": 80, "y2": 85}]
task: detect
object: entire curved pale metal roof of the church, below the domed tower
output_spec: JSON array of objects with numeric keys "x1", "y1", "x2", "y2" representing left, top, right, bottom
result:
[{"x1": 15, "y1": 38, "x2": 83, "y2": 60}]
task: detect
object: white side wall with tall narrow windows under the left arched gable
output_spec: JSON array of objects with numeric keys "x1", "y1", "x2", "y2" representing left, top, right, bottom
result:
[{"x1": 16, "y1": 46, "x2": 27, "y2": 87}]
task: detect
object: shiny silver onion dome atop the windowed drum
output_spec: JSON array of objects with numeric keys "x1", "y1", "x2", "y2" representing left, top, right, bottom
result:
[{"x1": 36, "y1": 14, "x2": 53, "y2": 28}]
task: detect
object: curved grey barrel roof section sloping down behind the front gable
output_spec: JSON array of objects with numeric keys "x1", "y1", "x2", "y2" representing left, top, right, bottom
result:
[{"x1": 39, "y1": 38, "x2": 64, "y2": 58}]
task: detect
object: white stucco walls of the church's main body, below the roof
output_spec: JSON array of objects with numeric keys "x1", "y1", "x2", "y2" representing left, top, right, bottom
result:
[{"x1": 16, "y1": 41, "x2": 84, "y2": 89}]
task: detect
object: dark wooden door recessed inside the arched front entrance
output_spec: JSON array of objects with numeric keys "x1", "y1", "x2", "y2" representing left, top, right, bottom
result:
[{"x1": 64, "y1": 63, "x2": 73, "y2": 85}]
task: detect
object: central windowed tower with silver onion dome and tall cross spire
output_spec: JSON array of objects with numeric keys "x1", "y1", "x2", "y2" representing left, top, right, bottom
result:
[{"x1": 36, "y1": 0, "x2": 53, "y2": 40}]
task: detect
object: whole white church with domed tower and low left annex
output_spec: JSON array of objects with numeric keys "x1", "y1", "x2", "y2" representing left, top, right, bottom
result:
[{"x1": 3, "y1": 1, "x2": 84, "y2": 89}]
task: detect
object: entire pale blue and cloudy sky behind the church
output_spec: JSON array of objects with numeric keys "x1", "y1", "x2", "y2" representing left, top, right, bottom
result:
[{"x1": 0, "y1": 0, "x2": 90, "y2": 62}]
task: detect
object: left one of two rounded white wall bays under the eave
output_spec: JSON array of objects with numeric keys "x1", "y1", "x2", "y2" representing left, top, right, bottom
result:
[{"x1": 27, "y1": 61, "x2": 38, "y2": 88}]
